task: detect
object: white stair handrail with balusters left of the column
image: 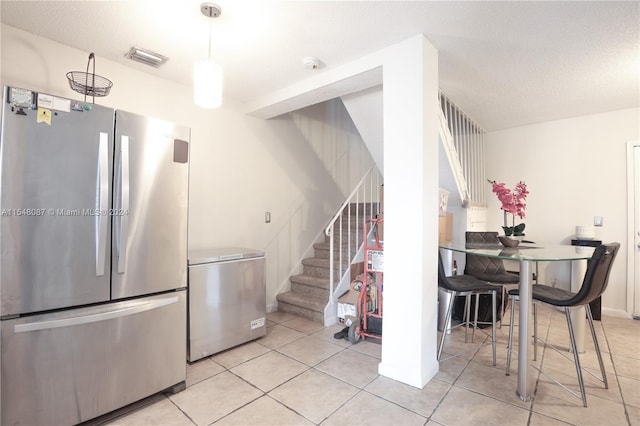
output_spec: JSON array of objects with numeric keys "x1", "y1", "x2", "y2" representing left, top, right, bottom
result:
[{"x1": 325, "y1": 165, "x2": 382, "y2": 301}]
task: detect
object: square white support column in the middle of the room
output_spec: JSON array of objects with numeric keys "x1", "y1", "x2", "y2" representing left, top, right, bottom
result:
[{"x1": 379, "y1": 35, "x2": 439, "y2": 388}]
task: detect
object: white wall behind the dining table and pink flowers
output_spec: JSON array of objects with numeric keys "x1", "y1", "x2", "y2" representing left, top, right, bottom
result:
[{"x1": 485, "y1": 108, "x2": 640, "y2": 314}]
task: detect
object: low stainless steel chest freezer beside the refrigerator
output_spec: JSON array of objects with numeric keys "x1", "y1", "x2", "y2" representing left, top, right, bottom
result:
[{"x1": 188, "y1": 247, "x2": 267, "y2": 362}]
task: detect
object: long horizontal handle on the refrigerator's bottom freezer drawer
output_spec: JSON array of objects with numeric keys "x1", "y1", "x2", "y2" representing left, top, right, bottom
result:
[{"x1": 13, "y1": 296, "x2": 179, "y2": 333}]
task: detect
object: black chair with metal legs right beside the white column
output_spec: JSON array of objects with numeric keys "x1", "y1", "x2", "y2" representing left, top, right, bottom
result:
[{"x1": 437, "y1": 251, "x2": 500, "y2": 365}]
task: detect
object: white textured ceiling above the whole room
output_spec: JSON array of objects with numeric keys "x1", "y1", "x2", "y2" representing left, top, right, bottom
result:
[{"x1": 0, "y1": 0, "x2": 640, "y2": 130}]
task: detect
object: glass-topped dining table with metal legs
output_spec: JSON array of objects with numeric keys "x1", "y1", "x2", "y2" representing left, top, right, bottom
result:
[{"x1": 439, "y1": 243, "x2": 595, "y2": 401}]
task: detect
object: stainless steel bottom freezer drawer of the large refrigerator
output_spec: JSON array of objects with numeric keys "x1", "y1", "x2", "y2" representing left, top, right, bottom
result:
[{"x1": 0, "y1": 291, "x2": 186, "y2": 425}]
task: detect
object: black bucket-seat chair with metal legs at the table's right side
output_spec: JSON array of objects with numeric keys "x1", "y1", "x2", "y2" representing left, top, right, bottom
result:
[{"x1": 507, "y1": 243, "x2": 620, "y2": 407}]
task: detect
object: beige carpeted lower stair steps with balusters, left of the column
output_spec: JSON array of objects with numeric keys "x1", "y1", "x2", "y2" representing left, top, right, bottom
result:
[{"x1": 277, "y1": 203, "x2": 377, "y2": 324}]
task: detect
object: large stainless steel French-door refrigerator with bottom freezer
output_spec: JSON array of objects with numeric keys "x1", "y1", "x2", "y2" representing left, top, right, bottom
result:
[{"x1": 0, "y1": 87, "x2": 190, "y2": 425}]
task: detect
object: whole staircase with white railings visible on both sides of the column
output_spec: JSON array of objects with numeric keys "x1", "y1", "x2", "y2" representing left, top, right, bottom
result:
[{"x1": 277, "y1": 93, "x2": 486, "y2": 323}]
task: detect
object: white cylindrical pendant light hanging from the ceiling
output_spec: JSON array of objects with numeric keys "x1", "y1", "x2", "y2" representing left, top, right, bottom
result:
[{"x1": 193, "y1": 3, "x2": 222, "y2": 108}]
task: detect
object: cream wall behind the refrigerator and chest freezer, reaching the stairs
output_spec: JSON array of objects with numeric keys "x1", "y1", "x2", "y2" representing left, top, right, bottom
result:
[{"x1": 0, "y1": 25, "x2": 372, "y2": 309}]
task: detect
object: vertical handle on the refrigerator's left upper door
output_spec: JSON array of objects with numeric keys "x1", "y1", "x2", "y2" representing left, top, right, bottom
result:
[{"x1": 95, "y1": 132, "x2": 110, "y2": 277}]
